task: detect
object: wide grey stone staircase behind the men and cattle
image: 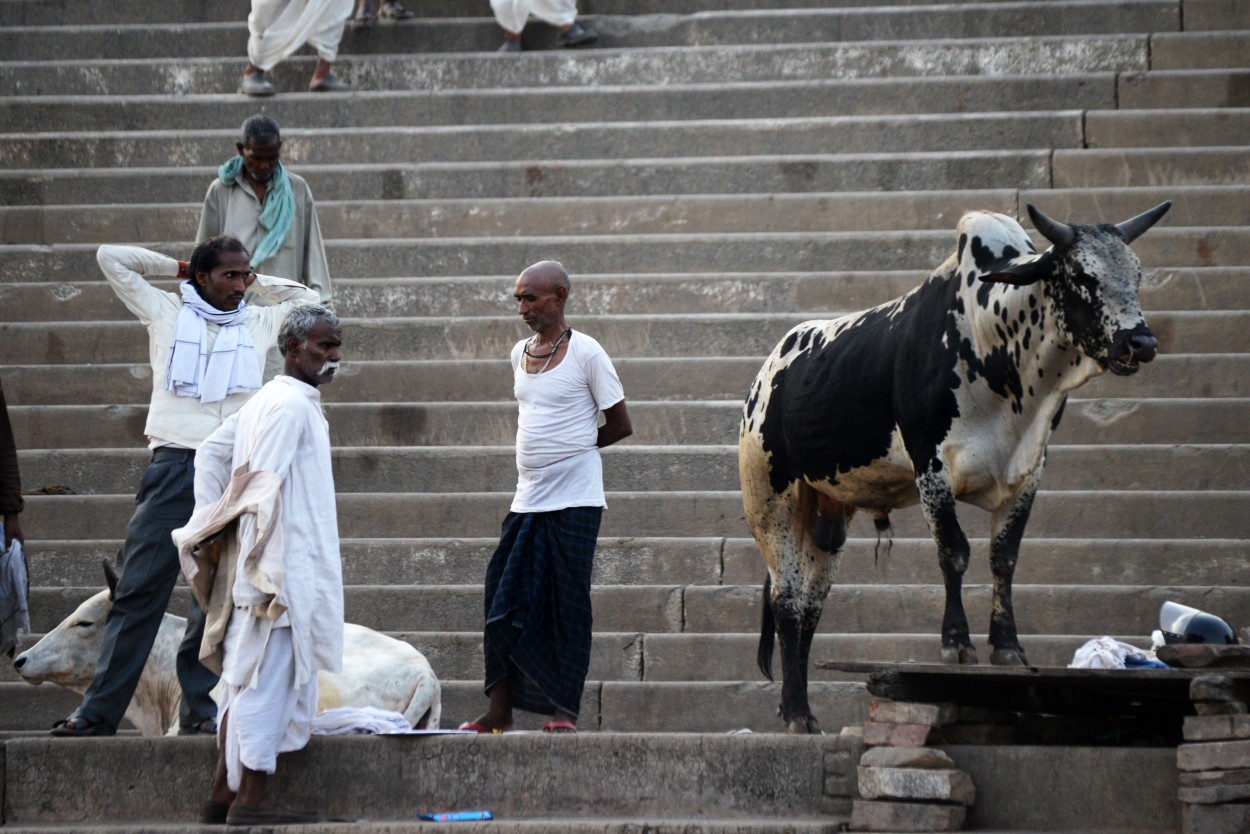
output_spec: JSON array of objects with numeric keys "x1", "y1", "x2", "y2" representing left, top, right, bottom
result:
[{"x1": 0, "y1": 0, "x2": 1250, "y2": 831}]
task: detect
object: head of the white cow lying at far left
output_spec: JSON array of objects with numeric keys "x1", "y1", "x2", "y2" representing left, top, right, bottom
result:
[{"x1": 13, "y1": 563, "x2": 118, "y2": 693}]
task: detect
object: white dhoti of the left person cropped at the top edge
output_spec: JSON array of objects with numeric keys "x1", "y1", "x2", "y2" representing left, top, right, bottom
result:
[{"x1": 248, "y1": 0, "x2": 355, "y2": 70}]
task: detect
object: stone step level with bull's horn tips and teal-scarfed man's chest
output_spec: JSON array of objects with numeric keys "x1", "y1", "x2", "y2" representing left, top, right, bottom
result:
[{"x1": 9, "y1": 185, "x2": 1250, "y2": 246}]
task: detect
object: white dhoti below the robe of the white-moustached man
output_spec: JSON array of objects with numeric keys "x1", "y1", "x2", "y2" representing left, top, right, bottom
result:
[{"x1": 218, "y1": 625, "x2": 318, "y2": 790}]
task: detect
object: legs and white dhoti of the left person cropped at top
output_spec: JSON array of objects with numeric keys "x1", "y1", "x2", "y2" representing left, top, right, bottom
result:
[{"x1": 239, "y1": 0, "x2": 355, "y2": 96}]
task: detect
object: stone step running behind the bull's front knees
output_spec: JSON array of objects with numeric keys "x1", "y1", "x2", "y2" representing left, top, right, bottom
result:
[{"x1": 29, "y1": 535, "x2": 1250, "y2": 589}]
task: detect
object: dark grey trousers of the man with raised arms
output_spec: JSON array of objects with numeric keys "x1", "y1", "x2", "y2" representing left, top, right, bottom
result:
[{"x1": 74, "y1": 448, "x2": 218, "y2": 729}]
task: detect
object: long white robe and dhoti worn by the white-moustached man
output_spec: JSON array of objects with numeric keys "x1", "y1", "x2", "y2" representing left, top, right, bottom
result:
[{"x1": 187, "y1": 376, "x2": 343, "y2": 784}]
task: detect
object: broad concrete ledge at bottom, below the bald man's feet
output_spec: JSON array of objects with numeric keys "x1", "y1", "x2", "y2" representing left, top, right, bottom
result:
[{"x1": 5, "y1": 733, "x2": 859, "y2": 825}]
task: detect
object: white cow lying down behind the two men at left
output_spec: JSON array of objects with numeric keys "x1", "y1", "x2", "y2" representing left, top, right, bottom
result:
[{"x1": 14, "y1": 575, "x2": 443, "y2": 735}]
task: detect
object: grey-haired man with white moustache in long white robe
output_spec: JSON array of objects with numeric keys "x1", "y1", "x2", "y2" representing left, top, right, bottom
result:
[{"x1": 174, "y1": 305, "x2": 343, "y2": 825}]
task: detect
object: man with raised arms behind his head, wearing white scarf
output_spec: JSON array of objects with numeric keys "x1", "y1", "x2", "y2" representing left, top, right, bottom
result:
[{"x1": 53, "y1": 236, "x2": 318, "y2": 736}]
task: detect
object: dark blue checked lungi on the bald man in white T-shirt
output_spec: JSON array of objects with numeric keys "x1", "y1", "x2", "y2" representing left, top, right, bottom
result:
[{"x1": 484, "y1": 506, "x2": 604, "y2": 716}]
